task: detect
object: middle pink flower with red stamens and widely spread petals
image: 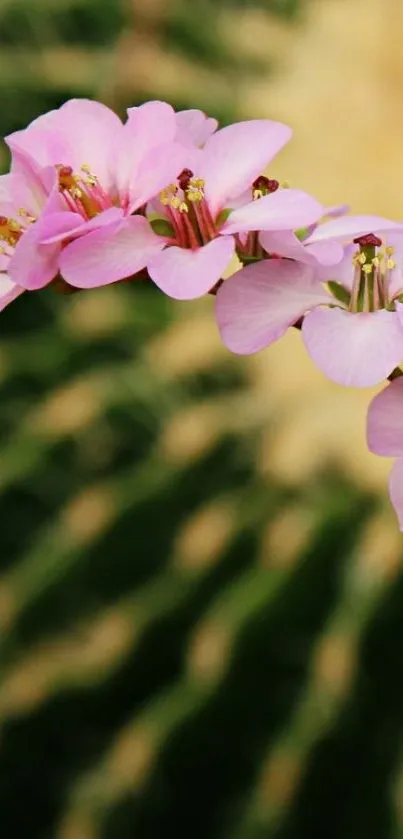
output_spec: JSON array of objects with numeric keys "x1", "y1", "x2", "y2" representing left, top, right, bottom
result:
[{"x1": 147, "y1": 120, "x2": 323, "y2": 300}]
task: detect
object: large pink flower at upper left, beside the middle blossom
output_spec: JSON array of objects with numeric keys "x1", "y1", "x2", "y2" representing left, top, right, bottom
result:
[{"x1": 7, "y1": 99, "x2": 189, "y2": 289}]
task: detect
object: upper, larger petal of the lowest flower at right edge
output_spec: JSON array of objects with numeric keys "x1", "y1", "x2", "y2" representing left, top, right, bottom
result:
[{"x1": 367, "y1": 378, "x2": 403, "y2": 457}]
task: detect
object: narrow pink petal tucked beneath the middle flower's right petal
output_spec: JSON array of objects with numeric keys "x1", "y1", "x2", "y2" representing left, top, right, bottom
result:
[{"x1": 259, "y1": 230, "x2": 344, "y2": 265}]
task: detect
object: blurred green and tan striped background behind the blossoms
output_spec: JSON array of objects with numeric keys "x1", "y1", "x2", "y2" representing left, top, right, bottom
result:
[{"x1": 0, "y1": 0, "x2": 403, "y2": 839}]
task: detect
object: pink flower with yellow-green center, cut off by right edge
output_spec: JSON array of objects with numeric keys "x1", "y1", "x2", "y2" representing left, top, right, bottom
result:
[{"x1": 216, "y1": 216, "x2": 403, "y2": 387}]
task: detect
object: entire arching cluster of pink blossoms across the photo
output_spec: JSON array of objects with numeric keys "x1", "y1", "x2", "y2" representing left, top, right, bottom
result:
[{"x1": 0, "y1": 99, "x2": 403, "y2": 530}]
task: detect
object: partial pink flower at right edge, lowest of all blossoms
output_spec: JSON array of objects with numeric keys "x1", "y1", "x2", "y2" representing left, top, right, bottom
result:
[{"x1": 367, "y1": 378, "x2": 403, "y2": 531}]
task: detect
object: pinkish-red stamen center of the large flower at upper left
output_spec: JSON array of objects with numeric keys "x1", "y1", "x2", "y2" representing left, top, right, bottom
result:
[{"x1": 56, "y1": 163, "x2": 113, "y2": 220}]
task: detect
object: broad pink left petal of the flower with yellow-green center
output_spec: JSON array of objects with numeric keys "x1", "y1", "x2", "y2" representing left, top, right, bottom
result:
[{"x1": 216, "y1": 259, "x2": 329, "y2": 355}]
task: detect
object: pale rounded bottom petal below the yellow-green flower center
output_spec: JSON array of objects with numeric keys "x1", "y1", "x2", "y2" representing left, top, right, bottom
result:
[{"x1": 302, "y1": 308, "x2": 403, "y2": 387}]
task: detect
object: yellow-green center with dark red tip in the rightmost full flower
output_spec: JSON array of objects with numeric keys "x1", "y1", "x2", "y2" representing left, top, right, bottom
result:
[{"x1": 349, "y1": 233, "x2": 396, "y2": 312}]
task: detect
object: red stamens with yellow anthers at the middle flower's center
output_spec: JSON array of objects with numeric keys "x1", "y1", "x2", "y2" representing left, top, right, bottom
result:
[{"x1": 159, "y1": 169, "x2": 218, "y2": 249}]
